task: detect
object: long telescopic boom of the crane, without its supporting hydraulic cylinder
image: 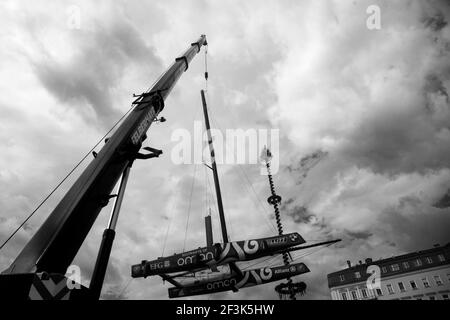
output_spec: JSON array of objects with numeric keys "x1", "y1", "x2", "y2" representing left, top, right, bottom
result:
[{"x1": 3, "y1": 35, "x2": 206, "y2": 274}]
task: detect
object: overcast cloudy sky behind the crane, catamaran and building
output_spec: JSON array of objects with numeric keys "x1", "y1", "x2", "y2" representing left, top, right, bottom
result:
[{"x1": 0, "y1": 0, "x2": 450, "y2": 299}]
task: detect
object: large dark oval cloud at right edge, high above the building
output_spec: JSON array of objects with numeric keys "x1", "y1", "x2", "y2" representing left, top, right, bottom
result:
[{"x1": 342, "y1": 84, "x2": 450, "y2": 175}]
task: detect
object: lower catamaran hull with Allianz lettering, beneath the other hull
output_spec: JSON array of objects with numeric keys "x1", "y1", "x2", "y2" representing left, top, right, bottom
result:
[{"x1": 169, "y1": 263, "x2": 310, "y2": 298}]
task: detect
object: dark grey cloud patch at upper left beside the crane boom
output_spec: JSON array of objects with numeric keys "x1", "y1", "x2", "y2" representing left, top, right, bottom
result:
[{"x1": 26, "y1": 17, "x2": 161, "y2": 128}]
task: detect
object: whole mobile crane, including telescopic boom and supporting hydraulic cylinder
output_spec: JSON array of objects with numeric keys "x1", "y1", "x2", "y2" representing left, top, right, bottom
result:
[{"x1": 0, "y1": 35, "x2": 207, "y2": 299}]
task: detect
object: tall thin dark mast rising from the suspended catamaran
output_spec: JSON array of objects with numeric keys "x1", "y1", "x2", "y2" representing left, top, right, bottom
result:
[{"x1": 200, "y1": 90, "x2": 228, "y2": 243}]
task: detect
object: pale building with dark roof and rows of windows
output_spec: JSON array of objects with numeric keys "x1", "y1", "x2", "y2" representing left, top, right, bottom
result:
[{"x1": 327, "y1": 243, "x2": 450, "y2": 300}]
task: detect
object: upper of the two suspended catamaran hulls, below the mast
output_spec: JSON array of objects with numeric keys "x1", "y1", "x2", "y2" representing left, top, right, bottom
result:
[{"x1": 131, "y1": 232, "x2": 305, "y2": 278}]
